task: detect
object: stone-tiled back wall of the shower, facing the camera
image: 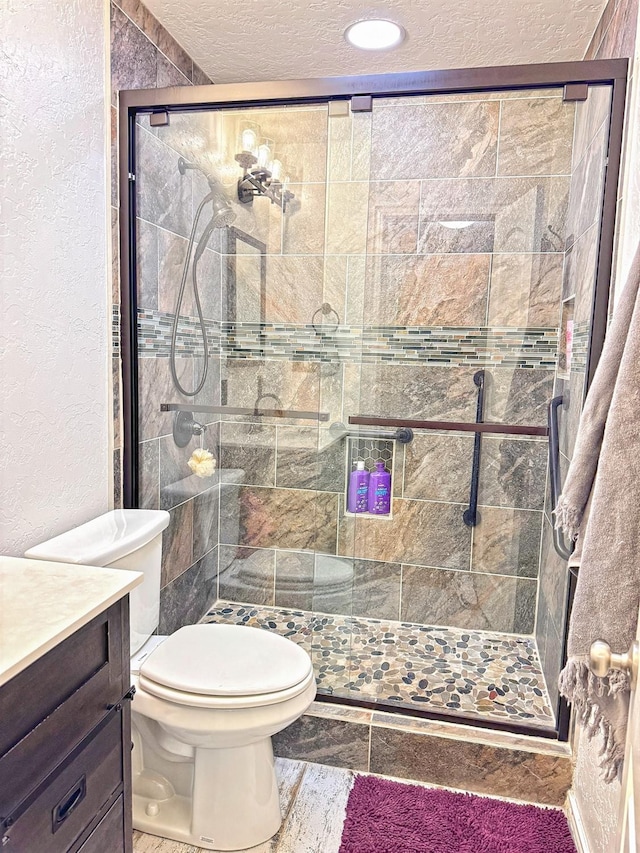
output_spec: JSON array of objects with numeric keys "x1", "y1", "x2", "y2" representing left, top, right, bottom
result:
[{"x1": 219, "y1": 91, "x2": 574, "y2": 633}]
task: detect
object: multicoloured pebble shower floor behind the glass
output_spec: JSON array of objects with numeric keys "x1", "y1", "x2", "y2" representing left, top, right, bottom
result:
[{"x1": 202, "y1": 601, "x2": 554, "y2": 728}]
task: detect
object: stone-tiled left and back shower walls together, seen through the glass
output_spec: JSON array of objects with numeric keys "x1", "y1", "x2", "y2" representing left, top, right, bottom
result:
[{"x1": 129, "y1": 90, "x2": 574, "y2": 633}]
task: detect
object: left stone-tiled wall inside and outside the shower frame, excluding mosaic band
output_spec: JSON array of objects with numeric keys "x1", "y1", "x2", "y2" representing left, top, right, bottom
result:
[{"x1": 110, "y1": 0, "x2": 220, "y2": 632}]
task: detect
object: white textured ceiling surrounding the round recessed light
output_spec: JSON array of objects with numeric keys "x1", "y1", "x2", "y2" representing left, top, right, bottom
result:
[{"x1": 145, "y1": 0, "x2": 606, "y2": 83}]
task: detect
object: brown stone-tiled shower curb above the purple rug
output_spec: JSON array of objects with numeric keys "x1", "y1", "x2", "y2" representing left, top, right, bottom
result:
[{"x1": 273, "y1": 703, "x2": 572, "y2": 805}]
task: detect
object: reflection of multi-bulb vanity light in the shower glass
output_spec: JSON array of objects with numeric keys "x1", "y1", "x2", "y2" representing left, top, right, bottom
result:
[{"x1": 235, "y1": 127, "x2": 295, "y2": 213}]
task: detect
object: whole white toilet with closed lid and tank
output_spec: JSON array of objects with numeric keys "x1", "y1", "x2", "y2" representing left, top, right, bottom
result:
[{"x1": 25, "y1": 510, "x2": 316, "y2": 850}]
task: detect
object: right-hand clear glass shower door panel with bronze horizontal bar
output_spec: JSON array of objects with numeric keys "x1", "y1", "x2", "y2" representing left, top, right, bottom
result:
[{"x1": 328, "y1": 87, "x2": 609, "y2": 728}]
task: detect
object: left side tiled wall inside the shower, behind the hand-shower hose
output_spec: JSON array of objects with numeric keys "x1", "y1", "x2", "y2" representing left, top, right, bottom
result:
[{"x1": 136, "y1": 117, "x2": 226, "y2": 633}]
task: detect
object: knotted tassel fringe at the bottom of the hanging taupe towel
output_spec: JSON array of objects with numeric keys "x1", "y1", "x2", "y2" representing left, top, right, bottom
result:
[{"x1": 558, "y1": 658, "x2": 630, "y2": 783}]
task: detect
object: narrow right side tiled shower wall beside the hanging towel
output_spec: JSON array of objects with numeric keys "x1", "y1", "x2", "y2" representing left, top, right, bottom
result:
[{"x1": 536, "y1": 86, "x2": 611, "y2": 712}]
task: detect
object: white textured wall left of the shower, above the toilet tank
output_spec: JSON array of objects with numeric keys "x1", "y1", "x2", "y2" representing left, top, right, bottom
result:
[{"x1": 0, "y1": 0, "x2": 110, "y2": 555}]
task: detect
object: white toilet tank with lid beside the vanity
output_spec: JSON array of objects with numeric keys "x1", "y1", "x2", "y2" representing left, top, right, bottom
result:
[{"x1": 25, "y1": 509, "x2": 169, "y2": 654}]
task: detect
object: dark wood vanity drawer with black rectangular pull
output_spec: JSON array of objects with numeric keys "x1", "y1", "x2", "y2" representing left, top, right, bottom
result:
[{"x1": 5, "y1": 709, "x2": 123, "y2": 853}]
